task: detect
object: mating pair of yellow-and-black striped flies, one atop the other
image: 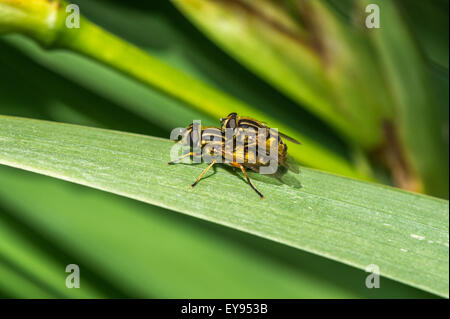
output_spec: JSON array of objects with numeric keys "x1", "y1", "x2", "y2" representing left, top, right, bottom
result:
[{"x1": 168, "y1": 113, "x2": 300, "y2": 199}]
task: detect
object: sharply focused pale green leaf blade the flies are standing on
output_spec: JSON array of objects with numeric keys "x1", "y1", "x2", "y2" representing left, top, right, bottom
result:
[{"x1": 0, "y1": 116, "x2": 449, "y2": 297}]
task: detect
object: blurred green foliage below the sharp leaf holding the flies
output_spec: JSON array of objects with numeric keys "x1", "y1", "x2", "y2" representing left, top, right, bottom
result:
[{"x1": 0, "y1": 165, "x2": 432, "y2": 298}]
